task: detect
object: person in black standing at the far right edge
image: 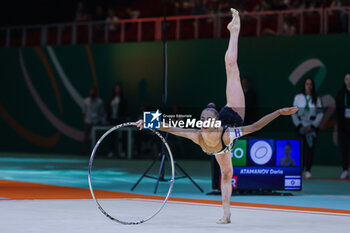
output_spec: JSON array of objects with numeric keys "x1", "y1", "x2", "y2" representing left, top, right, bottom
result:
[{"x1": 335, "y1": 72, "x2": 350, "y2": 179}]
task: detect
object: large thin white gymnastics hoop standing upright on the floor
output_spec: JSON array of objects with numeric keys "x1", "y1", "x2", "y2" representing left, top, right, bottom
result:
[{"x1": 88, "y1": 122, "x2": 175, "y2": 225}]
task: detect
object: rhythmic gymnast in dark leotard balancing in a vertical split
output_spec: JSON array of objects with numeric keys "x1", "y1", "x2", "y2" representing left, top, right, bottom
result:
[{"x1": 136, "y1": 8, "x2": 298, "y2": 224}]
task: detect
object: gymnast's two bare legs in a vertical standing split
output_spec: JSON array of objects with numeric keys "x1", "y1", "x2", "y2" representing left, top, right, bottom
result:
[{"x1": 215, "y1": 9, "x2": 245, "y2": 224}]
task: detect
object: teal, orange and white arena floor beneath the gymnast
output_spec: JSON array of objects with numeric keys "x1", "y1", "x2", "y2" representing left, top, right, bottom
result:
[{"x1": 0, "y1": 153, "x2": 350, "y2": 233}]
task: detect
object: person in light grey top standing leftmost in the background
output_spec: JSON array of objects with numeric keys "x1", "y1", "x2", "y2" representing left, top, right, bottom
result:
[{"x1": 83, "y1": 87, "x2": 105, "y2": 155}]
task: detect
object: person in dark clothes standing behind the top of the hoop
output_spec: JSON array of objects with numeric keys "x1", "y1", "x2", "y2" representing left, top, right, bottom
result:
[{"x1": 107, "y1": 85, "x2": 126, "y2": 157}]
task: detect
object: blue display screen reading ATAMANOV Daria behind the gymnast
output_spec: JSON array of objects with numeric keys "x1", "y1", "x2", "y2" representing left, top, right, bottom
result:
[{"x1": 232, "y1": 139, "x2": 302, "y2": 190}]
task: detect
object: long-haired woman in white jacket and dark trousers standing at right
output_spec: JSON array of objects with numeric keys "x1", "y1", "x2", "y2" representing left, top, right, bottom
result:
[{"x1": 292, "y1": 78, "x2": 323, "y2": 179}]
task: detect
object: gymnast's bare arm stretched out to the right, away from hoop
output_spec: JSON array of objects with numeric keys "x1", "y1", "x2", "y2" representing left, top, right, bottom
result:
[{"x1": 241, "y1": 107, "x2": 298, "y2": 136}]
